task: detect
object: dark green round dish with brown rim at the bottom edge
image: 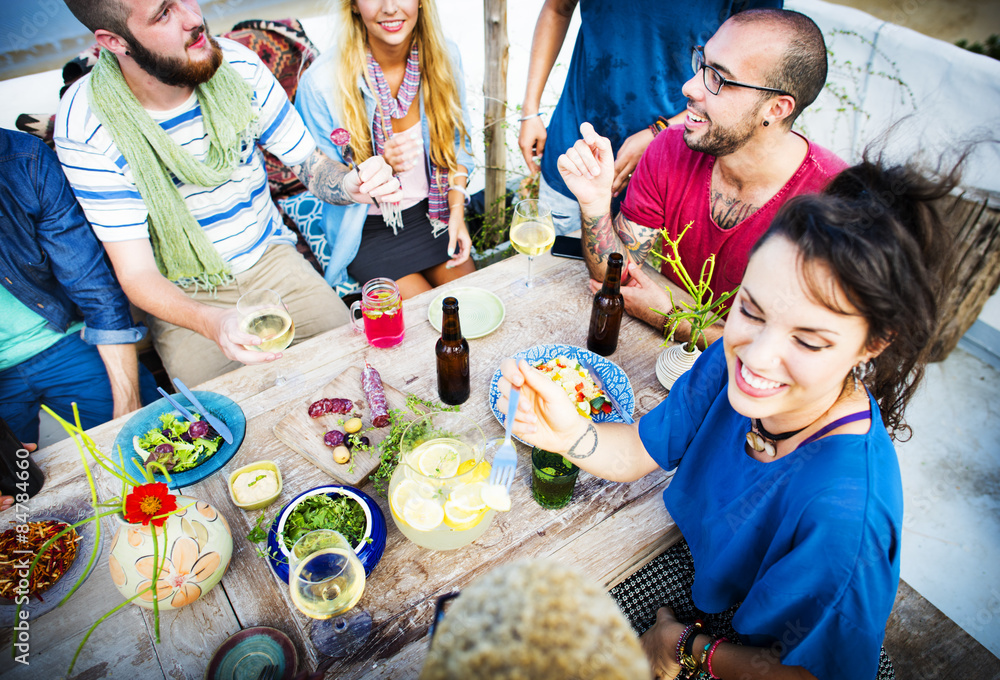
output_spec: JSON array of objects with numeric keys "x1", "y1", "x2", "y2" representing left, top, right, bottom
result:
[{"x1": 204, "y1": 628, "x2": 298, "y2": 680}]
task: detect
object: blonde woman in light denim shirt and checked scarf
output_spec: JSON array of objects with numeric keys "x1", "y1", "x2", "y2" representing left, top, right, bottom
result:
[{"x1": 295, "y1": 0, "x2": 475, "y2": 298}]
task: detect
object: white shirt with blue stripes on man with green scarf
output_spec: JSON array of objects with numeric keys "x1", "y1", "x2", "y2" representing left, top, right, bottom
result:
[{"x1": 55, "y1": 38, "x2": 316, "y2": 274}]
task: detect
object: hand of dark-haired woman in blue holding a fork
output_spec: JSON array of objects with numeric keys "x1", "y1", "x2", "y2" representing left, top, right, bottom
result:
[{"x1": 497, "y1": 359, "x2": 590, "y2": 453}]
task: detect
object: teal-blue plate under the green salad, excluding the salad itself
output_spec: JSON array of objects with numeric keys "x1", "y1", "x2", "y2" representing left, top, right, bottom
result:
[{"x1": 111, "y1": 390, "x2": 247, "y2": 489}]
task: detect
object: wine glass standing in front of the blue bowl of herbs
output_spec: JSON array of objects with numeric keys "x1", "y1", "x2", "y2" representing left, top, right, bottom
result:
[{"x1": 288, "y1": 529, "x2": 371, "y2": 656}]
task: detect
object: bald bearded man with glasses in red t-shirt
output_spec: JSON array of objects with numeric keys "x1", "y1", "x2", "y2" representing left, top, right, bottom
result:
[{"x1": 558, "y1": 9, "x2": 846, "y2": 342}]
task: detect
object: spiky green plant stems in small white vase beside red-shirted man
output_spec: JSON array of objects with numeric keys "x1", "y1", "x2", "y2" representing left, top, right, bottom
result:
[{"x1": 650, "y1": 222, "x2": 739, "y2": 352}]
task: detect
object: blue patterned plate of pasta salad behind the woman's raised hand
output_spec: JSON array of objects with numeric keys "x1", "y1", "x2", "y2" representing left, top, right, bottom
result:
[{"x1": 490, "y1": 345, "x2": 635, "y2": 443}]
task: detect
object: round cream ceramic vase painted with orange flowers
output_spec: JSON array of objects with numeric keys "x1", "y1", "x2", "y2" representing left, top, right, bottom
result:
[{"x1": 108, "y1": 496, "x2": 233, "y2": 611}]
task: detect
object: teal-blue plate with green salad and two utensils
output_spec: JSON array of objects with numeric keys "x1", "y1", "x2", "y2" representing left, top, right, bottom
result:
[{"x1": 112, "y1": 390, "x2": 247, "y2": 489}]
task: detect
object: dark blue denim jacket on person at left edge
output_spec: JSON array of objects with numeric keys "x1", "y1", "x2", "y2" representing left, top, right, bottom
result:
[{"x1": 0, "y1": 128, "x2": 146, "y2": 345}]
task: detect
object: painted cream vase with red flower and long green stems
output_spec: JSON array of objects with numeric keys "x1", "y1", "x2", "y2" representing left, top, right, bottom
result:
[{"x1": 13, "y1": 404, "x2": 233, "y2": 676}]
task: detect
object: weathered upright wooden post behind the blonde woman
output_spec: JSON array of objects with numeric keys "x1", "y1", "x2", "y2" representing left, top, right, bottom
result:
[{"x1": 483, "y1": 0, "x2": 510, "y2": 239}]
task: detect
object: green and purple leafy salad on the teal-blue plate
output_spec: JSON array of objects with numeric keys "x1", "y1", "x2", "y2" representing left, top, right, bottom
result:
[{"x1": 132, "y1": 413, "x2": 222, "y2": 472}]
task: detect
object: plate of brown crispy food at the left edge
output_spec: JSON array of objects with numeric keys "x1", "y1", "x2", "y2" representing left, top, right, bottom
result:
[{"x1": 0, "y1": 502, "x2": 102, "y2": 628}]
